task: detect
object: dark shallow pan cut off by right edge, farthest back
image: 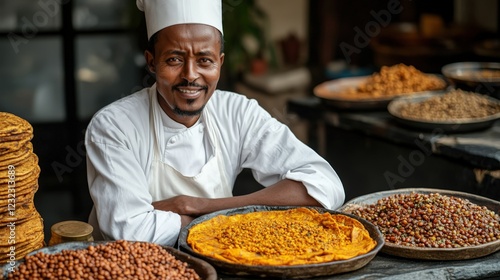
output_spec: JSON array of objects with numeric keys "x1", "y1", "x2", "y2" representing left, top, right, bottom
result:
[{"x1": 441, "y1": 62, "x2": 500, "y2": 99}]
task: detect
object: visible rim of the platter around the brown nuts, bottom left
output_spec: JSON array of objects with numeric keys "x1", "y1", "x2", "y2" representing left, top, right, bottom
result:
[{"x1": 1, "y1": 241, "x2": 218, "y2": 280}]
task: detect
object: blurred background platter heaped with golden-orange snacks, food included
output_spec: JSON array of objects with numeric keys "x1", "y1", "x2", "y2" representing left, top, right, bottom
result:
[{"x1": 313, "y1": 64, "x2": 448, "y2": 110}]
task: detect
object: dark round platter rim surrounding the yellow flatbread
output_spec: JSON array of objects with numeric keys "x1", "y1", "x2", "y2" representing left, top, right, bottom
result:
[{"x1": 178, "y1": 206, "x2": 384, "y2": 279}]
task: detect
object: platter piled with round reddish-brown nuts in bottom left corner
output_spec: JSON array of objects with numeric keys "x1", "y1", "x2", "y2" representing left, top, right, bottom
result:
[{"x1": 2, "y1": 240, "x2": 217, "y2": 280}]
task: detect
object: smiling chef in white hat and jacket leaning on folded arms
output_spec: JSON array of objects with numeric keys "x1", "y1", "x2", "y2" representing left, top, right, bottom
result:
[{"x1": 85, "y1": 0, "x2": 345, "y2": 245}]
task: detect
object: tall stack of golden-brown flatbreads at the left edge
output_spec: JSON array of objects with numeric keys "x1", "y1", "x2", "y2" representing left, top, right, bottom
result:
[{"x1": 0, "y1": 112, "x2": 44, "y2": 263}]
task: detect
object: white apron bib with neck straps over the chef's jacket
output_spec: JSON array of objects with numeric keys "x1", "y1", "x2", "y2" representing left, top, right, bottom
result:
[{"x1": 148, "y1": 88, "x2": 232, "y2": 201}]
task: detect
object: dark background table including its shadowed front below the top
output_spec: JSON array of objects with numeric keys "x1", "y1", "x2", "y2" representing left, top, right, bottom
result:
[{"x1": 287, "y1": 97, "x2": 500, "y2": 200}]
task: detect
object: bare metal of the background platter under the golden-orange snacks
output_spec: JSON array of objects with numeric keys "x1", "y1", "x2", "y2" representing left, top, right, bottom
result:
[{"x1": 313, "y1": 76, "x2": 446, "y2": 110}]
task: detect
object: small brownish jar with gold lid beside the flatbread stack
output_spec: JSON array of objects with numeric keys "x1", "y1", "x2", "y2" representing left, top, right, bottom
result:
[{"x1": 49, "y1": 221, "x2": 94, "y2": 246}]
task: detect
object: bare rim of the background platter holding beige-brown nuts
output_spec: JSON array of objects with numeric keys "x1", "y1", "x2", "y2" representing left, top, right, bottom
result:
[{"x1": 387, "y1": 92, "x2": 500, "y2": 133}]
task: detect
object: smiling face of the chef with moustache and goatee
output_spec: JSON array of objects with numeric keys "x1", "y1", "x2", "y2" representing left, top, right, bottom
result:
[{"x1": 145, "y1": 24, "x2": 224, "y2": 127}]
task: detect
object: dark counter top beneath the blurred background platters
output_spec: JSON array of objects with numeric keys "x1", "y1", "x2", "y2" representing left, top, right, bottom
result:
[{"x1": 288, "y1": 97, "x2": 500, "y2": 171}]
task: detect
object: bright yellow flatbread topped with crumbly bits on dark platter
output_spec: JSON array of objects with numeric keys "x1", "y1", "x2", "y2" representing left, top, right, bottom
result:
[{"x1": 187, "y1": 208, "x2": 377, "y2": 265}]
